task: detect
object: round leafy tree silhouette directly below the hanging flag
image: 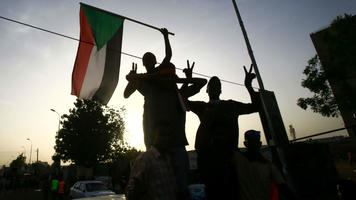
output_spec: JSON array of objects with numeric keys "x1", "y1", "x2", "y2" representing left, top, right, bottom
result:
[{"x1": 54, "y1": 99, "x2": 125, "y2": 167}]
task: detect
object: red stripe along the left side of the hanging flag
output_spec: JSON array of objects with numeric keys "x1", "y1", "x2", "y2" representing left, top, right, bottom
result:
[{"x1": 72, "y1": 7, "x2": 94, "y2": 97}]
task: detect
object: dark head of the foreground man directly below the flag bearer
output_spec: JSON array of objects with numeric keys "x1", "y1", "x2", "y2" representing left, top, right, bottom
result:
[{"x1": 153, "y1": 122, "x2": 173, "y2": 152}]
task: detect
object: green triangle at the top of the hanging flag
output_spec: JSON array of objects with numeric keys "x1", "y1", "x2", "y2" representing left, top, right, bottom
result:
[{"x1": 81, "y1": 4, "x2": 124, "y2": 51}]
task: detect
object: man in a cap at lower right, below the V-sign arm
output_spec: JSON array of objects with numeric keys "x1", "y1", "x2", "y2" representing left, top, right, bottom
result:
[{"x1": 233, "y1": 130, "x2": 295, "y2": 200}]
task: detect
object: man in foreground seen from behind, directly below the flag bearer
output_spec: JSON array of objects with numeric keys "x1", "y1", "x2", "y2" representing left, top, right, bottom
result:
[{"x1": 126, "y1": 123, "x2": 177, "y2": 200}]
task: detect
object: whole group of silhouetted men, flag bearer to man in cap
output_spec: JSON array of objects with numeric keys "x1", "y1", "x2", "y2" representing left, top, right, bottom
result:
[{"x1": 124, "y1": 29, "x2": 298, "y2": 200}]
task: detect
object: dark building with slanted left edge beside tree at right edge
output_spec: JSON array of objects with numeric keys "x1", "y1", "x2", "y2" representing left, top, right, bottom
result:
[{"x1": 310, "y1": 15, "x2": 356, "y2": 137}]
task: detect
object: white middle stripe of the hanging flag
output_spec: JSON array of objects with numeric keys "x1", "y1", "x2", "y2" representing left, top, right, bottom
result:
[{"x1": 79, "y1": 44, "x2": 106, "y2": 99}]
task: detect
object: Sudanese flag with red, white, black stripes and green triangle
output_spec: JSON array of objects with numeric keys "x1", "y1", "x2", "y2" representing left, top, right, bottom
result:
[{"x1": 71, "y1": 4, "x2": 124, "y2": 105}]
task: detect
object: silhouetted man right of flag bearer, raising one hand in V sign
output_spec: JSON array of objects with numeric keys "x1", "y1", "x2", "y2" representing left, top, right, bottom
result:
[{"x1": 188, "y1": 65, "x2": 259, "y2": 199}]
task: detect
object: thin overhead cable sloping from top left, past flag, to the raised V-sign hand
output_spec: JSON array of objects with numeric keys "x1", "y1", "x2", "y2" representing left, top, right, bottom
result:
[{"x1": 0, "y1": 16, "x2": 245, "y2": 86}]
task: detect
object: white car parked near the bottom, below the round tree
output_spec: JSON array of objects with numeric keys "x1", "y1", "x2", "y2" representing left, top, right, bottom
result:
[{"x1": 69, "y1": 181, "x2": 115, "y2": 199}]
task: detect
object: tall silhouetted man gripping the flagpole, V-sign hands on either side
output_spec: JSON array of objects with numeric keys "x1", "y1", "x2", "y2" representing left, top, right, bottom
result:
[{"x1": 124, "y1": 28, "x2": 206, "y2": 196}]
